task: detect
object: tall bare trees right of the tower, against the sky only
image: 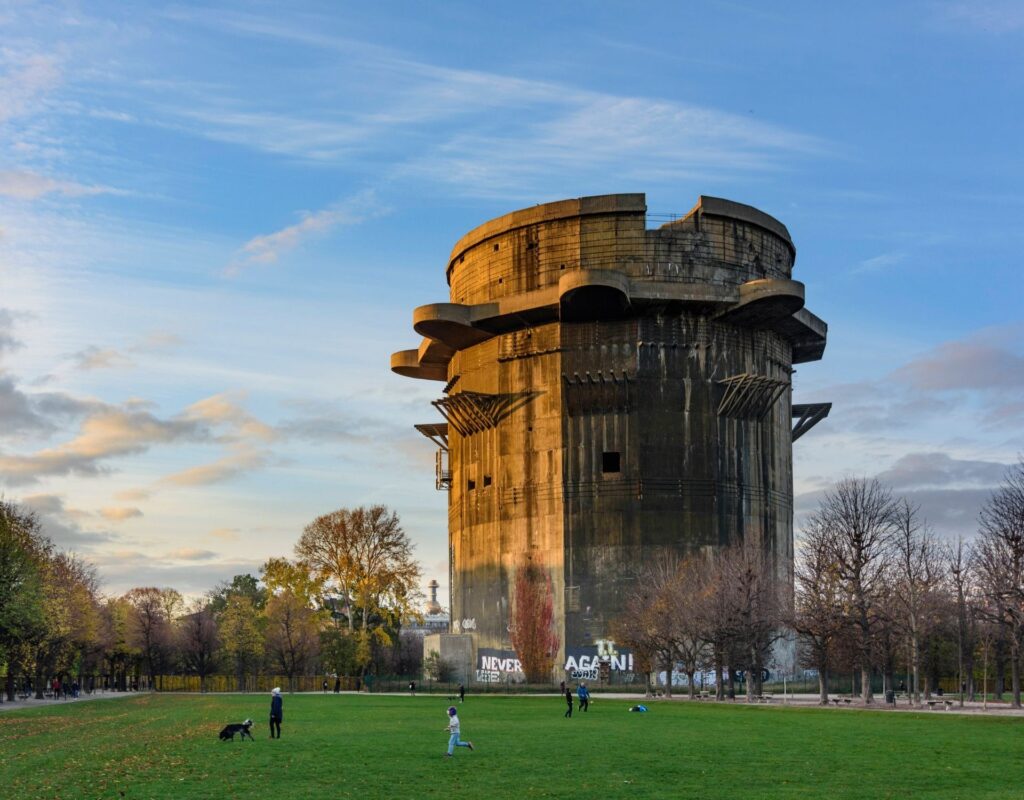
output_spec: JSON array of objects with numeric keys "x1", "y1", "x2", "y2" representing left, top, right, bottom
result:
[{"x1": 787, "y1": 462, "x2": 1024, "y2": 708}]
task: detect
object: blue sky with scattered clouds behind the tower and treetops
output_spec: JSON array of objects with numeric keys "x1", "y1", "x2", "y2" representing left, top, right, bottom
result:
[{"x1": 0, "y1": 0, "x2": 1024, "y2": 593}]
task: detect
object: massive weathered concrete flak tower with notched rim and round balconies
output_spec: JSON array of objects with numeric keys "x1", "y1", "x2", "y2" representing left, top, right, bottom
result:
[{"x1": 391, "y1": 195, "x2": 829, "y2": 668}]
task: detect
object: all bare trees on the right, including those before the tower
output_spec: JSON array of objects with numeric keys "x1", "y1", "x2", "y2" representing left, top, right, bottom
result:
[{"x1": 615, "y1": 461, "x2": 1024, "y2": 708}]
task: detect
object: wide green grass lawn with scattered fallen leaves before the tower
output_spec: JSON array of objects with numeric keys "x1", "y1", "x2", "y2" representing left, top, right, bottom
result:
[{"x1": 0, "y1": 694, "x2": 1024, "y2": 800}]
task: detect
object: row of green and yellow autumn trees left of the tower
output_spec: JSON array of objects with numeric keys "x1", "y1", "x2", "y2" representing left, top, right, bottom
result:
[{"x1": 0, "y1": 502, "x2": 422, "y2": 699}]
